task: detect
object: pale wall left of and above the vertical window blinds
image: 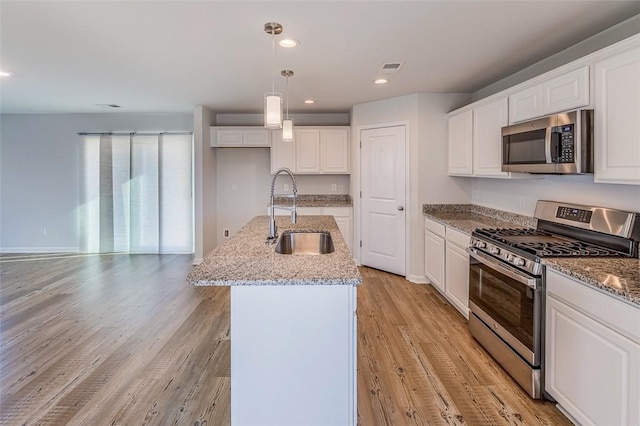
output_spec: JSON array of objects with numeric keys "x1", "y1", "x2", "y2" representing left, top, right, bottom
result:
[{"x1": 0, "y1": 113, "x2": 193, "y2": 252}]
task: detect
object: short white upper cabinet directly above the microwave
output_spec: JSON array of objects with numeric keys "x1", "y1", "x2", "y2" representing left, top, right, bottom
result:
[{"x1": 509, "y1": 66, "x2": 589, "y2": 123}]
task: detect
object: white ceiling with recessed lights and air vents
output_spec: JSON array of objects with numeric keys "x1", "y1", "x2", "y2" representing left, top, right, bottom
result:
[{"x1": 0, "y1": 0, "x2": 640, "y2": 113}]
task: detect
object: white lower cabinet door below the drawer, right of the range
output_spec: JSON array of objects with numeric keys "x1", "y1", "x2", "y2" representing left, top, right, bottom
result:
[{"x1": 545, "y1": 296, "x2": 640, "y2": 425}]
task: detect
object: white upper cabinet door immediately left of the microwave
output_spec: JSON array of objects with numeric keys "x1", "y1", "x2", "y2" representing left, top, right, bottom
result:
[{"x1": 473, "y1": 98, "x2": 509, "y2": 177}]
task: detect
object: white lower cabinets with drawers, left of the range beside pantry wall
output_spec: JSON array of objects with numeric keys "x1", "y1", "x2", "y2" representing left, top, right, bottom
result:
[{"x1": 424, "y1": 218, "x2": 469, "y2": 318}]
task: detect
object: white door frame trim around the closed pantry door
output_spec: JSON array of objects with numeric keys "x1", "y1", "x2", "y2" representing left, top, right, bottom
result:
[{"x1": 351, "y1": 120, "x2": 413, "y2": 278}]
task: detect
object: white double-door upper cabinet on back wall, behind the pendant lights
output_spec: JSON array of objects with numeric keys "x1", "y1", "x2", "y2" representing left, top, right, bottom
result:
[{"x1": 271, "y1": 126, "x2": 350, "y2": 174}]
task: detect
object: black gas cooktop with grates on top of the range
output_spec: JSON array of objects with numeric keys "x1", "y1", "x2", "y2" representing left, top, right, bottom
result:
[{"x1": 472, "y1": 228, "x2": 624, "y2": 257}]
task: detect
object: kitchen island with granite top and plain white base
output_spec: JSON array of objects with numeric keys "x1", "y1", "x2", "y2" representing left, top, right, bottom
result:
[{"x1": 187, "y1": 216, "x2": 362, "y2": 425}]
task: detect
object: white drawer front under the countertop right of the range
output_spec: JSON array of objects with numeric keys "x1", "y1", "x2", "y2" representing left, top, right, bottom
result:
[{"x1": 546, "y1": 269, "x2": 640, "y2": 343}]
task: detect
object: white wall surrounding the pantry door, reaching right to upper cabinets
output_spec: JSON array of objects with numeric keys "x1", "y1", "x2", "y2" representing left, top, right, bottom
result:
[{"x1": 351, "y1": 93, "x2": 471, "y2": 281}]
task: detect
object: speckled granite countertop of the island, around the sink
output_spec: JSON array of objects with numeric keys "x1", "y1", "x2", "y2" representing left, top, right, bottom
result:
[{"x1": 187, "y1": 216, "x2": 362, "y2": 286}]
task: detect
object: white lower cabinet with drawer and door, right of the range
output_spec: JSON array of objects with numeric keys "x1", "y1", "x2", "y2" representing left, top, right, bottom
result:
[{"x1": 545, "y1": 269, "x2": 640, "y2": 425}]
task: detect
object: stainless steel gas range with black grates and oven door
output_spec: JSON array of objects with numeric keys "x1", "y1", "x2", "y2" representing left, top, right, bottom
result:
[{"x1": 467, "y1": 201, "x2": 640, "y2": 398}]
